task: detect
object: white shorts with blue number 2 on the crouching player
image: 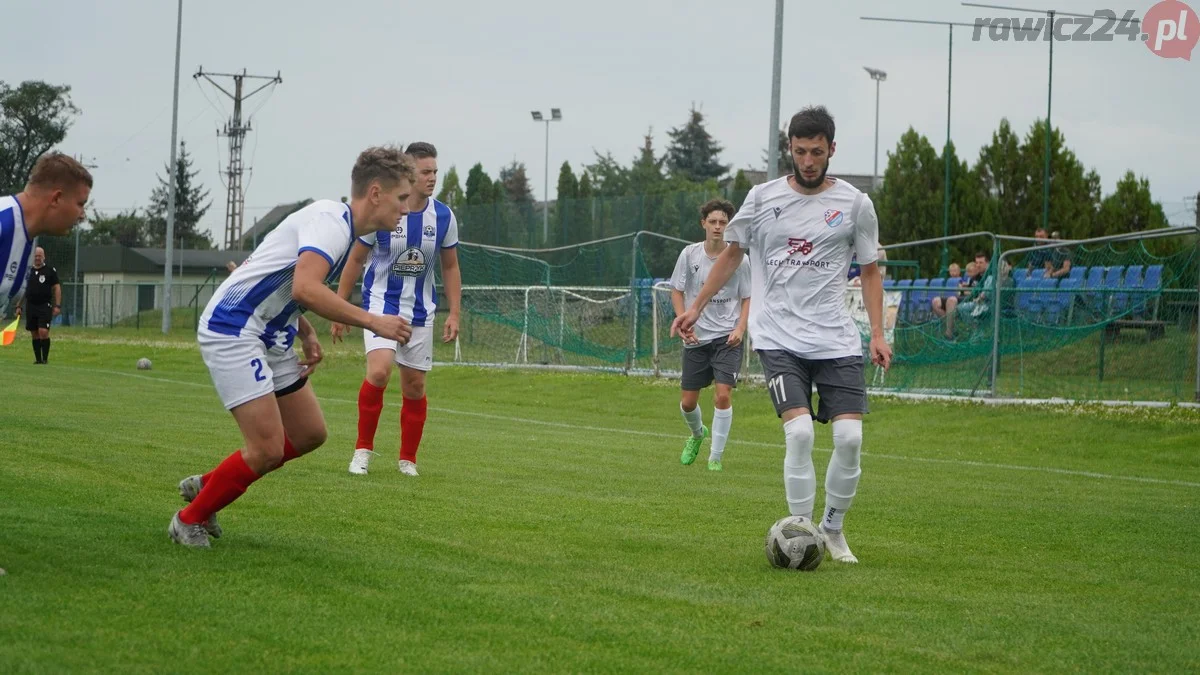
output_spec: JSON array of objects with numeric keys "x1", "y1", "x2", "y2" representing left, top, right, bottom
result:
[{"x1": 197, "y1": 331, "x2": 302, "y2": 410}]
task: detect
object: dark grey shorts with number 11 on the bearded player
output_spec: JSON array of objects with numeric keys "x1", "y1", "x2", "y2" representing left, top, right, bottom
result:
[{"x1": 758, "y1": 350, "x2": 870, "y2": 423}]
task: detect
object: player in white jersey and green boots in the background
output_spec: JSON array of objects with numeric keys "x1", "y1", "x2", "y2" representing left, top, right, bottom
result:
[{"x1": 671, "y1": 199, "x2": 750, "y2": 471}]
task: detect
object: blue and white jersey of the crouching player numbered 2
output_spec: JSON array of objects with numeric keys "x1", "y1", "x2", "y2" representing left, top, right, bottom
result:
[{"x1": 199, "y1": 199, "x2": 354, "y2": 353}]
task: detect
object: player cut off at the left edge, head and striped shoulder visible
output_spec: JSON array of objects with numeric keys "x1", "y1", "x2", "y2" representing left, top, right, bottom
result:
[{"x1": 0, "y1": 153, "x2": 92, "y2": 319}]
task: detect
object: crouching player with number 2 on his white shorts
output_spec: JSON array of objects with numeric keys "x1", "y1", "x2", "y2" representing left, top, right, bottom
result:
[{"x1": 167, "y1": 147, "x2": 413, "y2": 548}]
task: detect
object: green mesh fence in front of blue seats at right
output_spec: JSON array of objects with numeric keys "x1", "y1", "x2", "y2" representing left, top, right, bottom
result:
[{"x1": 882, "y1": 229, "x2": 1200, "y2": 401}]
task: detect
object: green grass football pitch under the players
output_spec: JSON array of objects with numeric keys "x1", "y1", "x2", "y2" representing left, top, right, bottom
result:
[{"x1": 0, "y1": 330, "x2": 1200, "y2": 673}]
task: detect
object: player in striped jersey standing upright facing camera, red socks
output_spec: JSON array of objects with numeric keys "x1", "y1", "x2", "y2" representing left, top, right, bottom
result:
[{"x1": 332, "y1": 143, "x2": 462, "y2": 476}]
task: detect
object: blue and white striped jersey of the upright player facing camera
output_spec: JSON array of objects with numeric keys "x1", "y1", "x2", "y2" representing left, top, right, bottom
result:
[{"x1": 359, "y1": 199, "x2": 458, "y2": 327}]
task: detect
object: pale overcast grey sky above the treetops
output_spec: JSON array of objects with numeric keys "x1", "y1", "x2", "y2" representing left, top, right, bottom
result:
[{"x1": 0, "y1": 0, "x2": 1200, "y2": 241}]
